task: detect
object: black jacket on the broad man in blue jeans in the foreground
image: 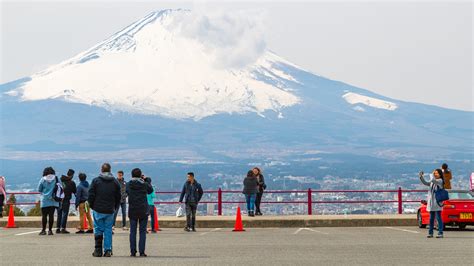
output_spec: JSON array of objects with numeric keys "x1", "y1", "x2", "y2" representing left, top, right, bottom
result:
[{"x1": 87, "y1": 173, "x2": 122, "y2": 214}]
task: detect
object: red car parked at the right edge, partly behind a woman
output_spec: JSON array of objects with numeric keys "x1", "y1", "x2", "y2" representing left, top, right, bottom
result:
[{"x1": 417, "y1": 190, "x2": 474, "y2": 229}]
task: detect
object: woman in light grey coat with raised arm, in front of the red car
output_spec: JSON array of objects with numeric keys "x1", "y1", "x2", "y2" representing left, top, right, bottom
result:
[{"x1": 420, "y1": 169, "x2": 444, "y2": 238}]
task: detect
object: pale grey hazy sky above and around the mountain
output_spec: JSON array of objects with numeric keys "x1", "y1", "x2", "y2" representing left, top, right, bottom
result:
[{"x1": 0, "y1": 1, "x2": 474, "y2": 111}]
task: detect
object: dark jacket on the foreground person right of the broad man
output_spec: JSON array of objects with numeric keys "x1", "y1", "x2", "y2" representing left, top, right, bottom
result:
[{"x1": 126, "y1": 177, "x2": 153, "y2": 220}]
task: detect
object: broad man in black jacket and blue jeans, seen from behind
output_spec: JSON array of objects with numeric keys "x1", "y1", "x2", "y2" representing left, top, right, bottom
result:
[{"x1": 87, "y1": 163, "x2": 122, "y2": 257}]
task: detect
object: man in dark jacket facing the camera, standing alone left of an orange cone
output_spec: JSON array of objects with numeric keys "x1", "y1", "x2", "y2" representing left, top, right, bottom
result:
[{"x1": 179, "y1": 172, "x2": 204, "y2": 232}]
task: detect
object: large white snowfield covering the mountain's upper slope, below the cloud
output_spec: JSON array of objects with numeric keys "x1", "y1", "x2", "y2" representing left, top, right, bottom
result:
[{"x1": 7, "y1": 10, "x2": 300, "y2": 120}]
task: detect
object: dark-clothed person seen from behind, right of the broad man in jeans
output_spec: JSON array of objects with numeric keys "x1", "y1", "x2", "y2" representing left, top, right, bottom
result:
[{"x1": 126, "y1": 168, "x2": 153, "y2": 257}]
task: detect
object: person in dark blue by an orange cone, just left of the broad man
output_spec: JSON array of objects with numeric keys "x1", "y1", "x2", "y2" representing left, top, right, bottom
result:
[{"x1": 75, "y1": 173, "x2": 94, "y2": 234}]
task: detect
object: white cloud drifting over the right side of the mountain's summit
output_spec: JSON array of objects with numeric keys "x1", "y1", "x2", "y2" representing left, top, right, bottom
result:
[{"x1": 170, "y1": 8, "x2": 266, "y2": 68}]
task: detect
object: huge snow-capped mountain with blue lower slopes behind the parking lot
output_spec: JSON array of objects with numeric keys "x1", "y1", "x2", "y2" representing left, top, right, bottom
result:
[{"x1": 0, "y1": 10, "x2": 474, "y2": 163}]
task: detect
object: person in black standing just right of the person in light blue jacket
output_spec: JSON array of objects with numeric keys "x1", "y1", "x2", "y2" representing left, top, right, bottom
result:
[{"x1": 56, "y1": 169, "x2": 76, "y2": 234}]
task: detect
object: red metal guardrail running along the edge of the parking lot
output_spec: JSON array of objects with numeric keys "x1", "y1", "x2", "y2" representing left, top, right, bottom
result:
[{"x1": 7, "y1": 187, "x2": 427, "y2": 215}]
